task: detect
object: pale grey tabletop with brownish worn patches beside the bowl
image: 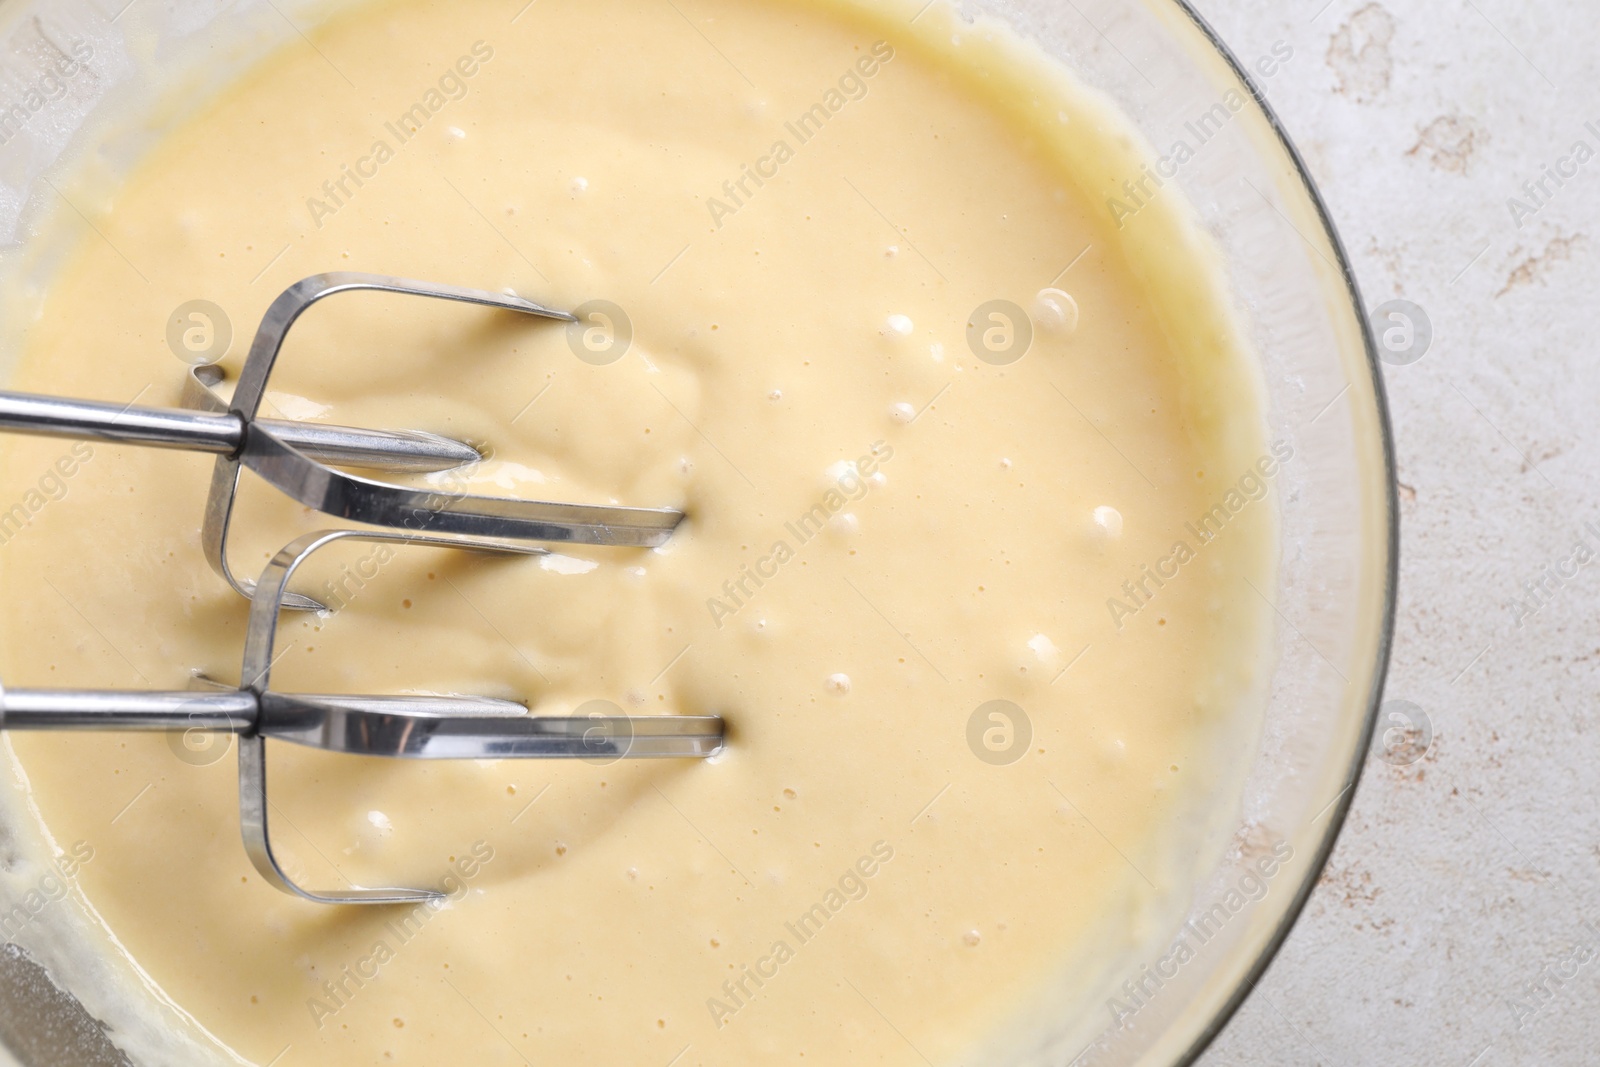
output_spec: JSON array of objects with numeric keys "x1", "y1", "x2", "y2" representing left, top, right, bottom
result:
[{"x1": 1195, "y1": 0, "x2": 1600, "y2": 1067}]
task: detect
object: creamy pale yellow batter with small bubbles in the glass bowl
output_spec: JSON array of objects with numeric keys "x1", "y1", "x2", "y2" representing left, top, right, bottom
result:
[{"x1": 0, "y1": 0, "x2": 1290, "y2": 1067}]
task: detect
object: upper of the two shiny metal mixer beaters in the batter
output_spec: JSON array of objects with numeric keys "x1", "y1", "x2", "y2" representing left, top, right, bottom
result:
[{"x1": 0, "y1": 272, "x2": 683, "y2": 609}]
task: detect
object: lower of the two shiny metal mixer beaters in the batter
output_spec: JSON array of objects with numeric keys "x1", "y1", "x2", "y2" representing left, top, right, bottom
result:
[{"x1": 0, "y1": 530, "x2": 723, "y2": 904}]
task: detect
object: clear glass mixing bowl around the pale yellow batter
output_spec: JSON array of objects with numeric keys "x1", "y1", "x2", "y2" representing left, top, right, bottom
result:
[{"x1": 0, "y1": 0, "x2": 1398, "y2": 1067}]
